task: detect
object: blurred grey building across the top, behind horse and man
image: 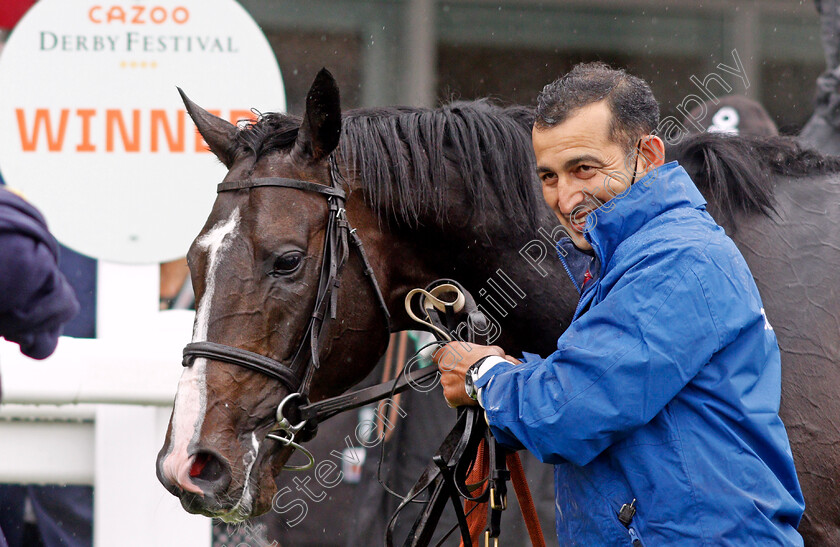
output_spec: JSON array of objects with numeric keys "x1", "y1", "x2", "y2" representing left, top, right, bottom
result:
[{"x1": 241, "y1": 0, "x2": 823, "y2": 132}]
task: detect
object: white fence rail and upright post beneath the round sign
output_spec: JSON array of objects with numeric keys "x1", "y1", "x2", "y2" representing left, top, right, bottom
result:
[{"x1": 0, "y1": 263, "x2": 211, "y2": 547}]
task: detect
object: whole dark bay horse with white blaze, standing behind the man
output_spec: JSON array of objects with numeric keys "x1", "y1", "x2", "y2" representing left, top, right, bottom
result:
[{"x1": 158, "y1": 71, "x2": 840, "y2": 544}]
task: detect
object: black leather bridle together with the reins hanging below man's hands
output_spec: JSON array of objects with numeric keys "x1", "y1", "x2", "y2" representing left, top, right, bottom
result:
[{"x1": 183, "y1": 168, "x2": 542, "y2": 546}]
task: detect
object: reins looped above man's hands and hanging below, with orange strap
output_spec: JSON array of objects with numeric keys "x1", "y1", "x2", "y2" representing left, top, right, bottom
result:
[{"x1": 380, "y1": 279, "x2": 545, "y2": 547}]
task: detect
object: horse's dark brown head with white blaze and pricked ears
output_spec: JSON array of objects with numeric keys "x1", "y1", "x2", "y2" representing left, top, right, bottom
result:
[{"x1": 157, "y1": 70, "x2": 398, "y2": 521}]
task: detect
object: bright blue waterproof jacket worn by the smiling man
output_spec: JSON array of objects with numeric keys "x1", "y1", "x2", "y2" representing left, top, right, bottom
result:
[{"x1": 476, "y1": 162, "x2": 804, "y2": 547}]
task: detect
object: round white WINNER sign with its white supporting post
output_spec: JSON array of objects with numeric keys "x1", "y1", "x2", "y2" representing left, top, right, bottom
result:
[{"x1": 0, "y1": 0, "x2": 285, "y2": 546}]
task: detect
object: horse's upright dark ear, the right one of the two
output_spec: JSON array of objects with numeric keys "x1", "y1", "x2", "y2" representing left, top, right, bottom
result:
[{"x1": 294, "y1": 68, "x2": 341, "y2": 161}]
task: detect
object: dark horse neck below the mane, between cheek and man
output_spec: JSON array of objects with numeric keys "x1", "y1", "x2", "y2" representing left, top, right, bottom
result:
[{"x1": 348, "y1": 191, "x2": 578, "y2": 353}]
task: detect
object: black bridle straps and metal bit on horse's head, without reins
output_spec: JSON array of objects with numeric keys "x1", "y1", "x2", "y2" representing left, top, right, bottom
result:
[{"x1": 182, "y1": 155, "x2": 391, "y2": 470}]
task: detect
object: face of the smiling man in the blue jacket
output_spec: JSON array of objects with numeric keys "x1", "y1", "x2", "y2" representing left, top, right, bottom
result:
[{"x1": 531, "y1": 101, "x2": 642, "y2": 250}]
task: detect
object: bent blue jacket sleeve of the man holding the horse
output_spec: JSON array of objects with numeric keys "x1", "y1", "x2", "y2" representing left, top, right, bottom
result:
[{"x1": 479, "y1": 249, "x2": 720, "y2": 465}]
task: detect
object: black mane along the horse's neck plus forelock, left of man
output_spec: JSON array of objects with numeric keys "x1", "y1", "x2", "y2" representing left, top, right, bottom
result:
[{"x1": 237, "y1": 100, "x2": 543, "y2": 230}]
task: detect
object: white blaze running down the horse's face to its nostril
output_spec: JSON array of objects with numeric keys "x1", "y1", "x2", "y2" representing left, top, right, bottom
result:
[{"x1": 162, "y1": 207, "x2": 240, "y2": 494}]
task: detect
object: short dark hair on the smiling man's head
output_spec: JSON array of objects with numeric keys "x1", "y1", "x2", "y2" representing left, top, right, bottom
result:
[{"x1": 534, "y1": 62, "x2": 659, "y2": 150}]
